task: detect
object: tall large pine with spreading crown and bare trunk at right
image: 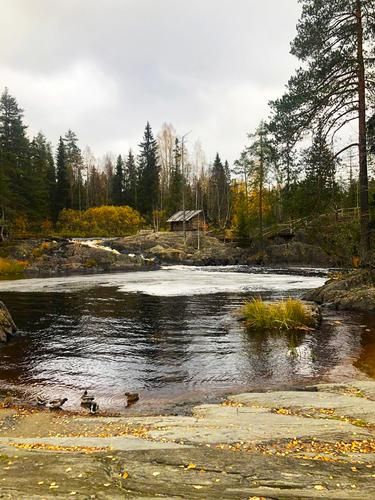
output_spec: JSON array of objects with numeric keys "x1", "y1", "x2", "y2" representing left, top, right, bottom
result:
[{"x1": 273, "y1": 0, "x2": 375, "y2": 256}]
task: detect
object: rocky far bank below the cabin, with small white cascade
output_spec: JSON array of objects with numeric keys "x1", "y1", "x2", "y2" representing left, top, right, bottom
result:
[{"x1": 0, "y1": 232, "x2": 335, "y2": 277}]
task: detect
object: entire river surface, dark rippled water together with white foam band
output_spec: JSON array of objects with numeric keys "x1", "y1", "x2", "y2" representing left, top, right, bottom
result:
[{"x1": 0, "y1": 266, "x2": 375, "y2": 412}]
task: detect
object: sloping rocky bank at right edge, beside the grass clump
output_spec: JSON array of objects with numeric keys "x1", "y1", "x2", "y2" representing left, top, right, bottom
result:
[{"x1": 304, "y1": 269, "x2": 375, "y2": 311}]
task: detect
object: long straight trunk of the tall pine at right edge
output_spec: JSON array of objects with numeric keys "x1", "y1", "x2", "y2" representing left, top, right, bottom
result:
[{"x1": 355, "y1": 0, "x2": 370, "y2": 260}]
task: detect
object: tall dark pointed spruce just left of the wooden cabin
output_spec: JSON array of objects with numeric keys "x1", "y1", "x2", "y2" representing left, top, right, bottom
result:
[{"x1": 137, "y1": 122, "x2": 159, "y2": 220}]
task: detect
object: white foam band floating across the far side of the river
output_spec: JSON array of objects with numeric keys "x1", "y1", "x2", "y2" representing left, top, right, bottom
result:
[{"x1": 0, "y1": 266, "x2": 326, "y2": 297}]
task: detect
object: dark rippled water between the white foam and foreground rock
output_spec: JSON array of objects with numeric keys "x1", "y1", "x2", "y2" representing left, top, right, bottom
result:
[{"x1": 0, "y1": 287, "x2": 375, "y2": 409}]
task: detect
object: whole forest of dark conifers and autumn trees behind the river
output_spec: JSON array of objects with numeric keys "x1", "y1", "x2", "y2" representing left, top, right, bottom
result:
[{"x1": 0, "y1": 0, "x2": 375, "y2": 254}]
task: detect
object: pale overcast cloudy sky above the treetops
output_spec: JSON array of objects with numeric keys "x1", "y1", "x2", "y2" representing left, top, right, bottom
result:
[{"x1": 0, "y1": 0, "x2": 300, "y2": 162}]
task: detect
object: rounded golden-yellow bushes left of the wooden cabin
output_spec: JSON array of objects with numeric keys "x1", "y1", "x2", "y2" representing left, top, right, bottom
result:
[{"x1": 57, "y1": 206, "x2": 144, "y2": 237}]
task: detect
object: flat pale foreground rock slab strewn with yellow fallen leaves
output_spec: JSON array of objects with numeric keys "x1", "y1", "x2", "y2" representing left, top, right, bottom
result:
[{"x1": 0, "y1": 381, "x2": 375, "y2": 499}]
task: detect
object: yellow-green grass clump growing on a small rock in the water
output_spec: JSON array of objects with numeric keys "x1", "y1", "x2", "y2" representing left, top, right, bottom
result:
[{"x1": 241, "y1": 298, "x2": 315, "y2": 330}]
